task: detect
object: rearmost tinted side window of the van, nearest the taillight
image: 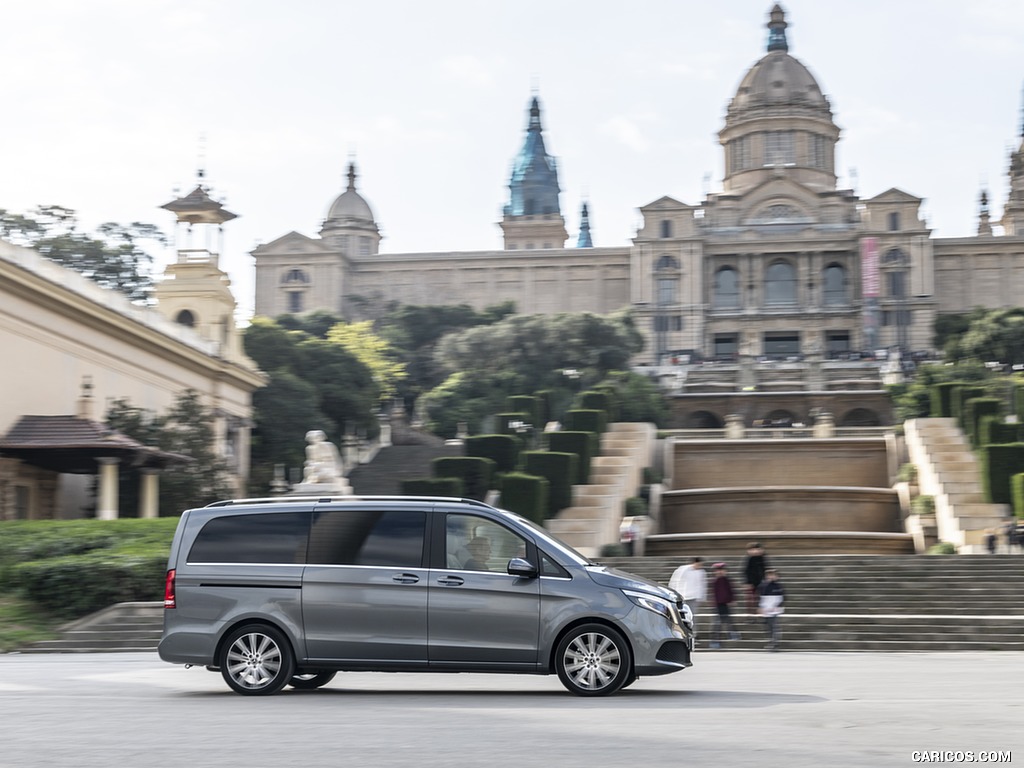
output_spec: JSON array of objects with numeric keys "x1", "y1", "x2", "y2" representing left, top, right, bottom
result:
[{"x1": 188, "y1": 512, "x2": 309, "y2": 564}]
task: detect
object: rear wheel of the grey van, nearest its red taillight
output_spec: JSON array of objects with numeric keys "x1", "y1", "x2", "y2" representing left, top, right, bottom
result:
[{"x1": 220, "y1": 624, "x2": 295, "y2": 696}]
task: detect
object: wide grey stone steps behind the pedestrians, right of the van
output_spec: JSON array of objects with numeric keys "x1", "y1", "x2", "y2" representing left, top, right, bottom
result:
[{"x1": 600, "y1": 552, "x2": 1024, "y2": 651}]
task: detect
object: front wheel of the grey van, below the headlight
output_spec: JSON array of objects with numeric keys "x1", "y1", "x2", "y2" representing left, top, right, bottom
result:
[{"x1": 555, "y1": 624, "x2": 634, "y2": 696}]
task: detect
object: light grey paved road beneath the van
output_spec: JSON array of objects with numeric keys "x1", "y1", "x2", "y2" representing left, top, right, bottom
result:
[{"x1": 0, "y1": 652, "x2": 1024, "y2": 768}]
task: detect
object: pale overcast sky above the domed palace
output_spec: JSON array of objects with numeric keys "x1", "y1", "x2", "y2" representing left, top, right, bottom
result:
[{"x1": 6, "y1": 0, "x2": 1024, "y2": 314}]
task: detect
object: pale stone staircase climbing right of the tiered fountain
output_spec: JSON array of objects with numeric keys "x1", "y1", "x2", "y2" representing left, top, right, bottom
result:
[{"x1": 904, "y1": 419, "x2": 1010, "y2": 554}]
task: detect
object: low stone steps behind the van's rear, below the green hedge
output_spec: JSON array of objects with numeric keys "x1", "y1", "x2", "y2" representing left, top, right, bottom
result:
[{"x1": 20, "y1": 602, "x2": 164, "y2": 653}]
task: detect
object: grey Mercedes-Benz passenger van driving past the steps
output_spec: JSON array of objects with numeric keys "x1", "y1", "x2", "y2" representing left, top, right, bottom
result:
[{"x1": 160, "y1": 497, "x2": 693, "y2": 696}]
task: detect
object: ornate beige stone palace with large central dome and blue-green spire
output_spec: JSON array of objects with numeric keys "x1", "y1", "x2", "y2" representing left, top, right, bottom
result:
[{"x1": 253, "y1": 5, "x2": 1024, "y2": 362}]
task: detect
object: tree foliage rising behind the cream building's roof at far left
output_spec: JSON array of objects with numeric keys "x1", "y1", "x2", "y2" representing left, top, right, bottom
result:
[{"x1": 0, "y1": 206, "x2": 167, "y2": 303}]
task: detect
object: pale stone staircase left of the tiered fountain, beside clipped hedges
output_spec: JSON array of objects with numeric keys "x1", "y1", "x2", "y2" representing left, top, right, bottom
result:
[{"x1": 545, "y1": 422, "x2": 655, "y2": 556}]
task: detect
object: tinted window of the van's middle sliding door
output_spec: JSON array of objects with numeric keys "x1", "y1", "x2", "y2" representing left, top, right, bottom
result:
[{"x1": 309, "y1": 510, "x2": 427, "y2": 568}]
